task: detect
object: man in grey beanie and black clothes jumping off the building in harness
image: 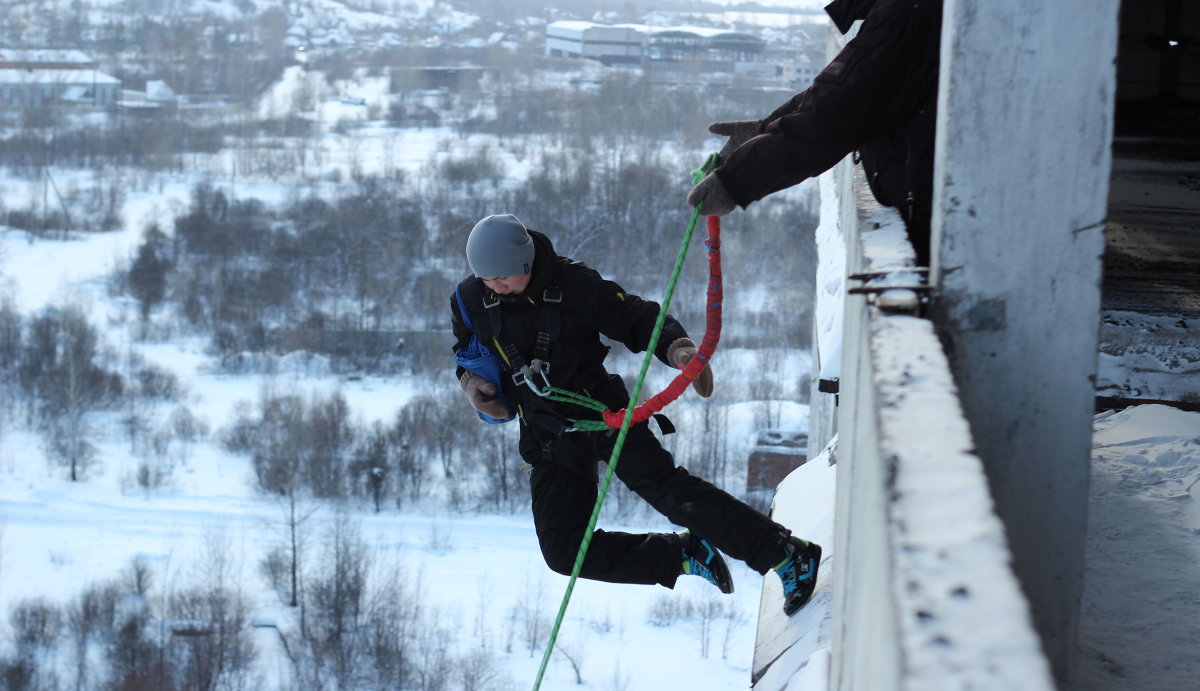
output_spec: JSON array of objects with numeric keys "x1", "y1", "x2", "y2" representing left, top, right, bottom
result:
[{"x1": 450, "y1": 215, "x2": 821, "y2": 614}]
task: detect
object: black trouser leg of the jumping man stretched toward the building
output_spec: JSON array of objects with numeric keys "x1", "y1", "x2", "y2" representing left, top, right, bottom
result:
[{"x1": 599, "y1": 423, "x2": 788, "y2": 573}]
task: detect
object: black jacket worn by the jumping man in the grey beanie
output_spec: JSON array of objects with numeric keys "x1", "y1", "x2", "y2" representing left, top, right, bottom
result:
[{"x1": 450, "y1": 230, "x2": 688, "y2": 446}]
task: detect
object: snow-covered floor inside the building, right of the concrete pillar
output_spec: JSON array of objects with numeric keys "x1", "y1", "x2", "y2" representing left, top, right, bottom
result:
[{"x1": 1079, "y1": 405, "x2": 1200, "y2": 691}]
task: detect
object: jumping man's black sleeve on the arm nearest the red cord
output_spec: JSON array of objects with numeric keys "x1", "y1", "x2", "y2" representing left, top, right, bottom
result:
[{"x1": 578, "y1": 268, "x2": 688, "y2": 363}]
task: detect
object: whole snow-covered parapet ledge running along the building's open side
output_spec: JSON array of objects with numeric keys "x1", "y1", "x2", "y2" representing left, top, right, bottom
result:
[{"x1": 823, "y1": 169, "x2": 1055, "y2": 691}]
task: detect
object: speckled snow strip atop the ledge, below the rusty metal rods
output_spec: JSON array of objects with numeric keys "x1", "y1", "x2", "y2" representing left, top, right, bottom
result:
[{"x1": 871, "y1": 316, "x2": 1055, "y2": 691}]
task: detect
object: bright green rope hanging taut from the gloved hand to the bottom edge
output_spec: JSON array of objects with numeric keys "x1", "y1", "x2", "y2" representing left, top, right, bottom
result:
[{"x1": 533, "y1": 154, "x2": 716, "y2": 691}]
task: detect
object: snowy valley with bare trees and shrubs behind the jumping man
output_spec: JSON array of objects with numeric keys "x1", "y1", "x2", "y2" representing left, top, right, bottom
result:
[{"x1": 0, "y1": 0, "x2": 816, "y2": 690}]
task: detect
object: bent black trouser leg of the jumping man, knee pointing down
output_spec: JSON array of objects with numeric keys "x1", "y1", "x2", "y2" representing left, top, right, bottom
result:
[{"x1": 529, "y1": 450, "x2": 683, "y2": 588}]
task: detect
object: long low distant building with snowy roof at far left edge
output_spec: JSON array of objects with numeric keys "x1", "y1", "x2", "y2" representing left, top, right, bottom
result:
[{"x1": 0, "y1": 49, "x2": 121, "y2": 108}]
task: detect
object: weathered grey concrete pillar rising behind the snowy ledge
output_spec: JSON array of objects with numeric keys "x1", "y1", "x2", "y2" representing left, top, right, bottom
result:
[{"x1": 934, "y1": 0, "x2": 1118, "y2": 686}]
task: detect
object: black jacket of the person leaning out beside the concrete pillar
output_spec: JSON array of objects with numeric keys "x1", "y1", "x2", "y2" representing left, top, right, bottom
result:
[{"x1": 715, "y1": 0, "x2": 942, "y2": 261}]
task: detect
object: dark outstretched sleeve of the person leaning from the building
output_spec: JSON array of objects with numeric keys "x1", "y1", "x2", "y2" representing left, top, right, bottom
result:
[{"x1": 716, "y1": 5, "x2": 928, "y2": 206}]
